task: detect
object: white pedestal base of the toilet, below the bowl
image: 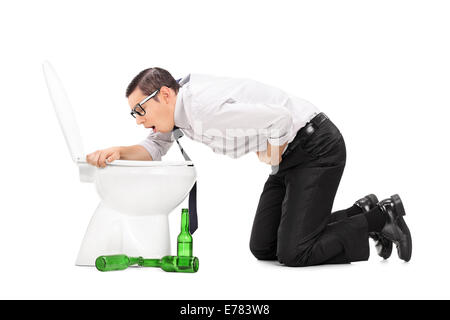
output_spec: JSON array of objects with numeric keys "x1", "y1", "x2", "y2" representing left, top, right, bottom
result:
[{"x1": 75, "y1": 202, "x2": 170, "y2": 266}]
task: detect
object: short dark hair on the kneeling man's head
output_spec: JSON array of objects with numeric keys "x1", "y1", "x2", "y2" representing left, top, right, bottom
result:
[{"x1": 125, "y1": 67, "x2": 180, "y2": 102}]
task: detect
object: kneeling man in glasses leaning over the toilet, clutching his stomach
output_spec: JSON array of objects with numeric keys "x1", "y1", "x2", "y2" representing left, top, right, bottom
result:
[{"x1": 87, "y1": 68, "x2": 412, "y2": 266}]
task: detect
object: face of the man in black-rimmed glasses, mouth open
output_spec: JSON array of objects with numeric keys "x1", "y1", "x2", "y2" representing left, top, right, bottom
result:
[{"x1": 128, "y1": 86, "x2": 176, "y2": 132}]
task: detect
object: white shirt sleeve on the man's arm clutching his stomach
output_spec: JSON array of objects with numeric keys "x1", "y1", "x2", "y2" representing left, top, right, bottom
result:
[{"x1": 195, "y1": 100, "x2": 293, "y2": 146}]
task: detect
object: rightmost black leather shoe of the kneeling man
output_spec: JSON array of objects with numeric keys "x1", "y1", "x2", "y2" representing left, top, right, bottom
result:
[{"x1": 377, "y1": 194, "x2": 412, "y2": 262}]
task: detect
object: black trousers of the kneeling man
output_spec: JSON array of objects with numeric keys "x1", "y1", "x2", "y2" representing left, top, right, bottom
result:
[{"x1": 250, "y1": 114, "x2": 369, "y2": 267}]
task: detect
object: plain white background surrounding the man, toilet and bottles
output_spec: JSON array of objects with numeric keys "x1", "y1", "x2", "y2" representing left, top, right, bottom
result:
[{"x1": 0, "y1": 0, "x2": 450, "y2": 299}]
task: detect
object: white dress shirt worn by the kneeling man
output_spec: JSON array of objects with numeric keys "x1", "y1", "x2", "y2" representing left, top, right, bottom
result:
[{"x1": 139, "y1": 73, "x2": 320, "y2": 160}]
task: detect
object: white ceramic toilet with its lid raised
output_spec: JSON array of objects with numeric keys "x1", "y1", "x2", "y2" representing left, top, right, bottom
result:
[{"x1": 43, "y1": 62, "x2": 196, "y2": 266}]
